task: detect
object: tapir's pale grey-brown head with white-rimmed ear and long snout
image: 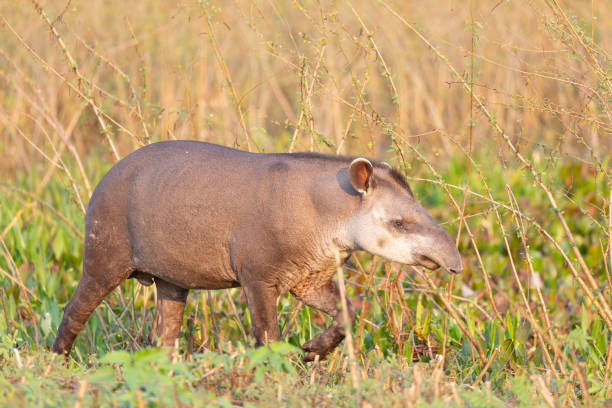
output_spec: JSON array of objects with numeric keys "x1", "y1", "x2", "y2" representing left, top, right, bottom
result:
[{"x1": 348, "y1": 158, "x2": 463, "y2": 273}]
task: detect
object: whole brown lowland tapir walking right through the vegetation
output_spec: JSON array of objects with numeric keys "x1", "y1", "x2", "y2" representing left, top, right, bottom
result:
[{"x1": 53, "y1": 141, "x2": 462, "y2": 360}]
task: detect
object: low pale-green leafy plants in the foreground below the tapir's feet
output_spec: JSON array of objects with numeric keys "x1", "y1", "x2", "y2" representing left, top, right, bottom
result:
[{"x1": 0, "y1": 343, "x2": 572, "y2": 407}]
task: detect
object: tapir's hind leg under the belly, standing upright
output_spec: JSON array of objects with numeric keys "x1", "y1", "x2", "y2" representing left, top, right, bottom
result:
[{"x1": 149, "y1": 278, "x2": 189, "y2": 346}]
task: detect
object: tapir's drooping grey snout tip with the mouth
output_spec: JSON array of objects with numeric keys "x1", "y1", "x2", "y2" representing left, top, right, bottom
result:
[{"x1": 414, "y1": 225, "x2": 463, "y2": 273}]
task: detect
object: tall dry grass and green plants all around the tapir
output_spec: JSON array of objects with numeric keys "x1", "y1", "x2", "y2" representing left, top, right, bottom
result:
[{"x1": 0, "y1": 0, "x2": 612, "y2": 407}]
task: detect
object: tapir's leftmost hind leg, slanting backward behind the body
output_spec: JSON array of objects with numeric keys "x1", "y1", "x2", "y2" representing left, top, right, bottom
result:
[{"x1": 52, "y1": 272, "x2": 129, "y2": 355}]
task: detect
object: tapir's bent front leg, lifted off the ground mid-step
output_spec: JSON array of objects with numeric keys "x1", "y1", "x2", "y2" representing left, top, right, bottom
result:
[{"x1": 291, "y1": 278, "x2": 355, "y2": 361}]
